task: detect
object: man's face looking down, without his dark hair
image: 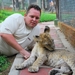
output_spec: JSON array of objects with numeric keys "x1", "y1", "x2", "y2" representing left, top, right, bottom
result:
[{"x1": 24, "y1": 8, "x2": 40, "y2": 28}]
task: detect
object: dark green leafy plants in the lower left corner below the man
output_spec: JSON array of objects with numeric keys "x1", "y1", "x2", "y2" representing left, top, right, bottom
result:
[{"x1": 0, "y1": 55, "x2": 10, "y2": 72}]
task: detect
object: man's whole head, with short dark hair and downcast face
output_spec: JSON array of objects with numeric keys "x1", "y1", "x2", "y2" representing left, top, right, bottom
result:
[{"x1": 25, "y1": 5, "x2": 41, "y2": 28}]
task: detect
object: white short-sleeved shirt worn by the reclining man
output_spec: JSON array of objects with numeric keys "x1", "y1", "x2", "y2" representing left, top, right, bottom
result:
[{"x1": 0, "y1": 13, "x2": 40, "y2": 55}]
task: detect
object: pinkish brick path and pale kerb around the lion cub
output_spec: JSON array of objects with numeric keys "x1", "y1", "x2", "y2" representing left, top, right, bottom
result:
[{"x1": 8, "y1": 21, "x2": 75, "y2": 75}]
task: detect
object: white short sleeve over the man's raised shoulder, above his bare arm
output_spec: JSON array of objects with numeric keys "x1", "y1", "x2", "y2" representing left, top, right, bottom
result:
[{"x1": 0, "y1": 14, "x2": 21, "y2": 34}]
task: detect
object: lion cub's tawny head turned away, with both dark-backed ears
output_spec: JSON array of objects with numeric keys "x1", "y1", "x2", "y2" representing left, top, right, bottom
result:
[{"x1": 34, "y1": 26, "x2": 55, "y2": 51}]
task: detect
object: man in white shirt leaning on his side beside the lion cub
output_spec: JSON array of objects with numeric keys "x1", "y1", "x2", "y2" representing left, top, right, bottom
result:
[{"x1": 0, "y1": 5, "x2": 41, "y2": 59}]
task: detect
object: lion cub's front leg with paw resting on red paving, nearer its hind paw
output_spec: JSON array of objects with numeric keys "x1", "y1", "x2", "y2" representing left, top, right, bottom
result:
[{"x1": 28, "y1": 56, "x2": 47, "y2": 72}]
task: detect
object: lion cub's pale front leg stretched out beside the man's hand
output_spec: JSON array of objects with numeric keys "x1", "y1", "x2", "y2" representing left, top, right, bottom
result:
[{"x1": 15, "y1": 46, "x2": 36, "y2": 70}]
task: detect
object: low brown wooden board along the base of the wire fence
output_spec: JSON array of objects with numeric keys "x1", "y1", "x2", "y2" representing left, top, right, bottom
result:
[{"x1": 58, "y1": 22, "x2": 75, "y2": 47}]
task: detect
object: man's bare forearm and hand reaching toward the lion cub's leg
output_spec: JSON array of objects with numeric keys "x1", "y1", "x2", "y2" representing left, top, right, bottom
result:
[{"x1": 0, "y1": 33, "x2": 30, "y2": 59}]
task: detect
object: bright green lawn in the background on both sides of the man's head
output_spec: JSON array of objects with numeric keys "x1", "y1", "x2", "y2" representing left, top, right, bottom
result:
[{"x1": 0, "y1": 10, "x2": 56, "y2": 22}]
